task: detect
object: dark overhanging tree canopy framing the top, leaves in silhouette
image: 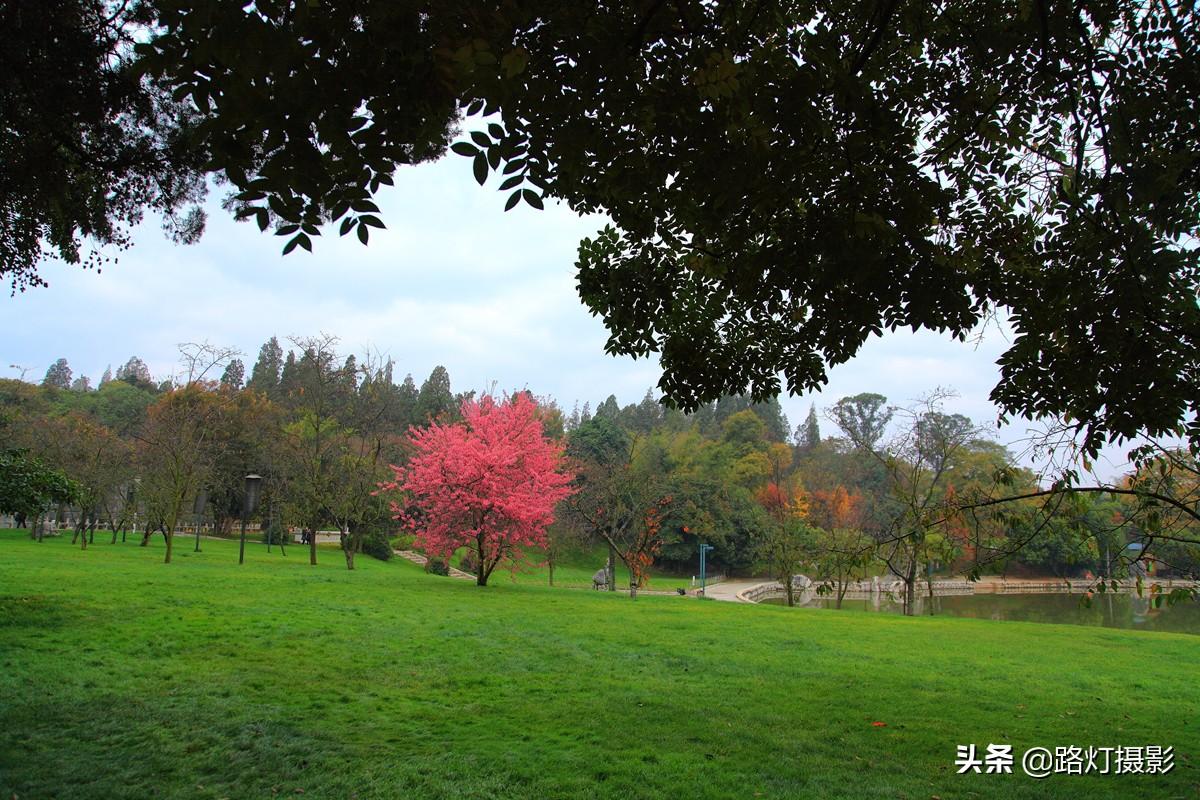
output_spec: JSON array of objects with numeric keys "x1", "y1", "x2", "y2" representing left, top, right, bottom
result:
[{"x1": 9, "y1": 0, "x2": 1200, "y2": 451}]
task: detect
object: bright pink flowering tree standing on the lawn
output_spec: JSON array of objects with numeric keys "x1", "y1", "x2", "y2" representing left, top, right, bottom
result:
[{"x1": 379, "y1": 393, "x2": 572, "y2": 587}]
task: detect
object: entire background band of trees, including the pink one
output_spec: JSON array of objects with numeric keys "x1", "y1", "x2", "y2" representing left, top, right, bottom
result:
[{"x1": 0, "y1": 336, "x2": 1200, "y2": 607}]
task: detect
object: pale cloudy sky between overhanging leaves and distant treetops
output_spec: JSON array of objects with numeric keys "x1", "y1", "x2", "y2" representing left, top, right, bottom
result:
[{"x1": 0, "y1": 149, "x2": 1123, "y2": 475}]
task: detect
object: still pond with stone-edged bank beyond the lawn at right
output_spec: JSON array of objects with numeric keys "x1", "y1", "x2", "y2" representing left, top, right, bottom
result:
[{"x1": 762, "y1": 593, "x2": 1200, "y2": 634}]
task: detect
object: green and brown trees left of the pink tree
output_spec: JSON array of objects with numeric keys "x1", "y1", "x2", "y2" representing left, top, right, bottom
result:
[{"x1": 0, "y1": 336, "x2": 472, "y2": 569}]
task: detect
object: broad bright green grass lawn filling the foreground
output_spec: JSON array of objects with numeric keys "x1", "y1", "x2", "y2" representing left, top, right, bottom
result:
[{"x1": 0, "y1": 533, "x2": 1200, "y2": 800}]
